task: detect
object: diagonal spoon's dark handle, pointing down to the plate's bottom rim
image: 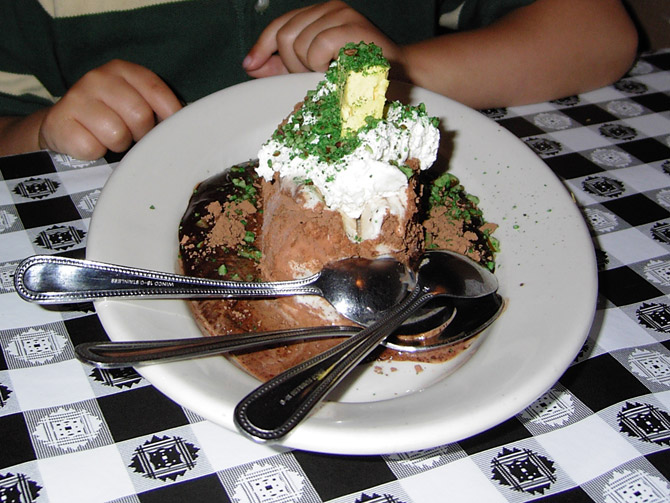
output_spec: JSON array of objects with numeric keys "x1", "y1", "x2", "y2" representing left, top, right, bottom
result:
[{"x1": 233, "y1": 288, "x2": 434, "y2": 441}]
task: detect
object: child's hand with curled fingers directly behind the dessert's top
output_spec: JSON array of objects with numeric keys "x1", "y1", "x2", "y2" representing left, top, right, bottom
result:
[{"x1": 243, "y1": 1, "x2": 401, "y2": 77}]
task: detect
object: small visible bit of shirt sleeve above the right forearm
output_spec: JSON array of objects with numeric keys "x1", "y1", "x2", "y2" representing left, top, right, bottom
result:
[{"x1": 440, "y1": 0, "x2": 535, "y2": 30}]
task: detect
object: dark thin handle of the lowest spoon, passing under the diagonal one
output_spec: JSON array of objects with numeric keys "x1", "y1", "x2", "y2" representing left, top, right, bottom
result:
[{"x1": 75, "y1": 326, "x2": 361, "y2": 368}]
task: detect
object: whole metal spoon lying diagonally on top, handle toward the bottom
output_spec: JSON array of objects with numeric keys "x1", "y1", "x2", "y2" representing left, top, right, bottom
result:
[{"x1": 233, "y1": 252, "x2": 498, "y2": 441}]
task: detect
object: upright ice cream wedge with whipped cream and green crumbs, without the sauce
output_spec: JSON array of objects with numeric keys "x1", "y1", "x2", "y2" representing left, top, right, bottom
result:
[{"x1": 256, "y1": 43, "x2": 440, "y2": 279}]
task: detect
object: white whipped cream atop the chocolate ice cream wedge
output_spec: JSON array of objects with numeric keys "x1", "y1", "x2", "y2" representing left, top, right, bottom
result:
[{"x1": 257, "y1": 85, "x2": 440, "y2": 240}]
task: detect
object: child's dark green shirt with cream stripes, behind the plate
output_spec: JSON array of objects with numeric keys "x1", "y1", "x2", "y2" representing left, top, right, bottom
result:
[{"x1": 0, "y1": 0, "x2": 533, "y2": 116}]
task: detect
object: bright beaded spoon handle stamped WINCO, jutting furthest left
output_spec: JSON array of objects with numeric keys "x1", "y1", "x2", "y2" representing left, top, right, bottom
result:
[{"x1": 14, "y1": 255, "x2": 321, "y2": 304}]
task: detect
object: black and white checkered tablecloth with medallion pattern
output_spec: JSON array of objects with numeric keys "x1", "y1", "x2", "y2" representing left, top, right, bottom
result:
[{"x1": 0, "y1": 51, "x2": 670, "y2": 503}]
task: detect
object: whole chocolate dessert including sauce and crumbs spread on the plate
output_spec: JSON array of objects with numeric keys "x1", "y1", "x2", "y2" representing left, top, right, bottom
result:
[{"x1": 179, "y1": 43, "x2": 495, "y2": 380}]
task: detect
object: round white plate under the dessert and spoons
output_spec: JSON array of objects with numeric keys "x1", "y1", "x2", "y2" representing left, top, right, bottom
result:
[{"x1": 87, "y1": 74, "x2": 596, "y2": 454}]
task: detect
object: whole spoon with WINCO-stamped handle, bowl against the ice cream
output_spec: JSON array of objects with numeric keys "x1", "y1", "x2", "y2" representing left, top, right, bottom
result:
[{"x1": 14, "y1": 255, "x2": 416, "y2": 325}]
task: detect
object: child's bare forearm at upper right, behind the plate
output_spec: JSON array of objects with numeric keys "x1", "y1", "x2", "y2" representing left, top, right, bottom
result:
[{"x1": 402, "y1": 0, "x2": 637, "y2": 108}]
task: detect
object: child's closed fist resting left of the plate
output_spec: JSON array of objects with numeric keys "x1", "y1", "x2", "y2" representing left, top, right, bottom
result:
[{"x1": 39, "y1": 60, "x2": 182, "y2": 159}]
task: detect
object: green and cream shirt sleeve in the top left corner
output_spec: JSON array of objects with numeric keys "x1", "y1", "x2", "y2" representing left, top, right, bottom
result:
[{"x1": 0, "y1": 0, "x2": 64, "y2": 116}]
